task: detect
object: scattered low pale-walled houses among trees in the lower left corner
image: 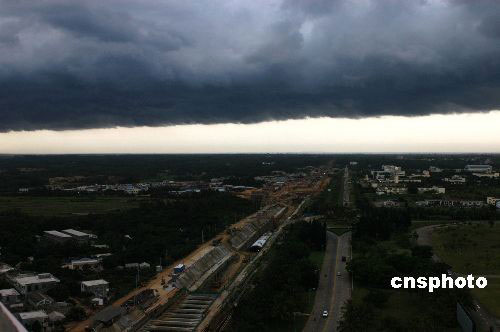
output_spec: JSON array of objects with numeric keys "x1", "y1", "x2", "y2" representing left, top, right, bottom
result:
[{"x1": 0, "y1": 229, "x2": 117, "y2": 331}]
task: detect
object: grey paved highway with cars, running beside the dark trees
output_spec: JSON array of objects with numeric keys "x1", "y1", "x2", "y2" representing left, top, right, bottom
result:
[{"x1": 304, "y1": 232, "x2": 352, "y2": 332}]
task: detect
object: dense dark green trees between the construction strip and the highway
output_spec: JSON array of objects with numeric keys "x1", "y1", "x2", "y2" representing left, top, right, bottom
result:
[{"x1": 231, "y1": 221, "x2": 326, "y2": 332}]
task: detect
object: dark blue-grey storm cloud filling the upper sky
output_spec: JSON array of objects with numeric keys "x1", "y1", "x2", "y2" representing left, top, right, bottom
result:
[{"x1": 0, "y1": 0, "x2": 500, "y2": 131}]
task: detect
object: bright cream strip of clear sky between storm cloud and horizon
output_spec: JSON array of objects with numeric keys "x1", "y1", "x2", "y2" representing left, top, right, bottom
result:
[{"x1": 0, "y1": 110, "x2": 500, "y2": 154}]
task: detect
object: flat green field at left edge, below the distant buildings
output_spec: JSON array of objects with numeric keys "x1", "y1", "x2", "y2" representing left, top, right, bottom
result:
[{"x1": 0, "y1": 196, "x2": 140, "y2": 216}]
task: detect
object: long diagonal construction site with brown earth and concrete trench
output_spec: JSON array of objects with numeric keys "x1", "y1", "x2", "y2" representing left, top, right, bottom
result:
[{"x1": 76, "y1": 173, "x2": 329, "y2": 332}]
